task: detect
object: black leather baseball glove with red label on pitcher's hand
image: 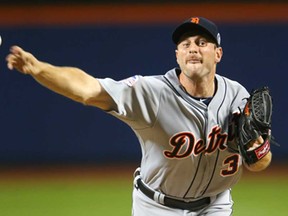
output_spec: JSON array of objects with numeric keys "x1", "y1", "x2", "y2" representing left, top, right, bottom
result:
[{"x1": 238, "y1": 87, "x2": 272, "y2": 165}]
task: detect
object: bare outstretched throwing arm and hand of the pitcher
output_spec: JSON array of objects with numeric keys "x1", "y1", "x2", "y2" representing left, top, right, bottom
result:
[{"x1": 6, "y1": 46, "x2": 115, "y2": 110}]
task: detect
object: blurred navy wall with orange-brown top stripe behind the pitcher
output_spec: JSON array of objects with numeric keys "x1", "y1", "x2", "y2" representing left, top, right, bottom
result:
[{"x1": 0, "y1": 0, "x2": 288, "y2": 166}]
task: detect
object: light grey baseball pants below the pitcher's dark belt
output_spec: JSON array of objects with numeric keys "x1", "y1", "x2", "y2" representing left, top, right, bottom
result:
[{"x1": 132, "y1": 188, "x2": 233, "y2": 216}]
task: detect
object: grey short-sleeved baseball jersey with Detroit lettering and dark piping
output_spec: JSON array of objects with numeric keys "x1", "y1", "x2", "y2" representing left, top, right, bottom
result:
[{"x1": 99, "y1": 69, "x2": 249, "y2": 200}]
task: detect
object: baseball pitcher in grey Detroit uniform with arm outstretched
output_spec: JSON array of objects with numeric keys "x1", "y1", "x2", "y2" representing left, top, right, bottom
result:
[{"x1": 6, "y1": 17, "x2": 272, "y2": 216}]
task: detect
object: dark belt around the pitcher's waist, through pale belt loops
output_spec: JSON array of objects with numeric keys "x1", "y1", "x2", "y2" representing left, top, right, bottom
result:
[{"x1": 134, "y1": 168, "x2": 211, "y2": 211}]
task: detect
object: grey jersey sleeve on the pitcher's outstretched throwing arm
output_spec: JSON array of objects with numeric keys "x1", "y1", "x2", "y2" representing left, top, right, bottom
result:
[{"x1": 98, "y1": 76, "x2": 160, "y2": 129}]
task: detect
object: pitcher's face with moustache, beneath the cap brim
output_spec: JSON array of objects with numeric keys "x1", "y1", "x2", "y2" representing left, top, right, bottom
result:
[{"x1": 176, "y1": 33, "x2": 222, "y2": 78}]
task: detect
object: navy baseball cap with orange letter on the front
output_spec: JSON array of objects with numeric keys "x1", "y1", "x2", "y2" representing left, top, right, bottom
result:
[{"x1": 172, "y1": 17, "x2": 221, "y2": 47}]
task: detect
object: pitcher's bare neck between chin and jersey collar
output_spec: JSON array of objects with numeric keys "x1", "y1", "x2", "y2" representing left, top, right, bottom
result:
[{"x1": 179, "y1": 72, "x2": 215, "y2": 98}]
